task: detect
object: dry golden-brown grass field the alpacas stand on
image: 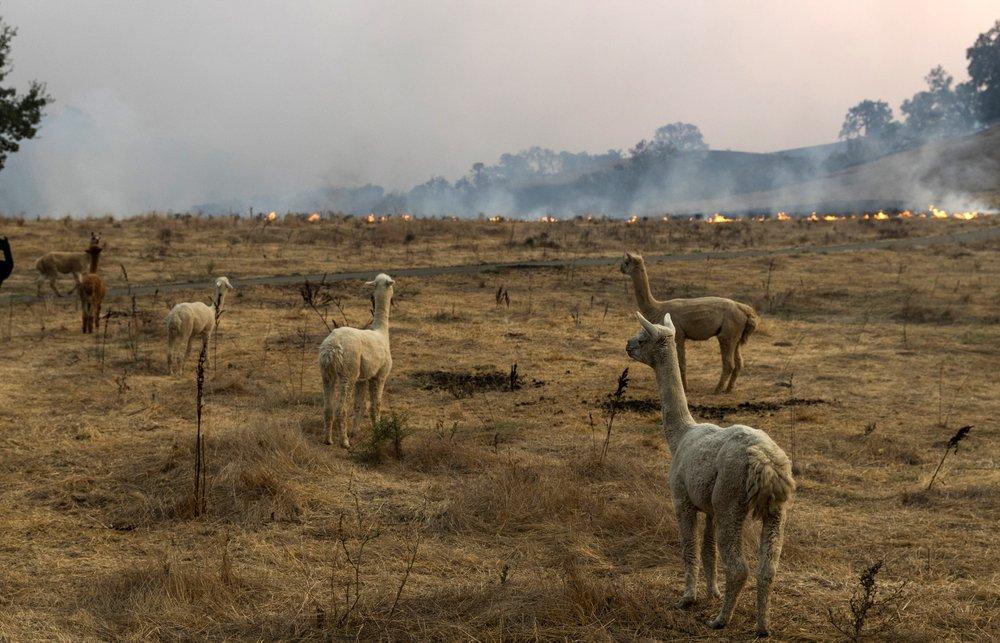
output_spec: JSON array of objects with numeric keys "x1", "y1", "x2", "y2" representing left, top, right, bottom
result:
[{"x1": 0, "y1": 217, "x2": 1000, "y2": 641}]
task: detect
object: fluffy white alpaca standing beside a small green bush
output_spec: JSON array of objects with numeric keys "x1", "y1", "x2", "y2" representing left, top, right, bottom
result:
[{"x1": 319, "y1": 274, "x2": 396, "y2": 449}]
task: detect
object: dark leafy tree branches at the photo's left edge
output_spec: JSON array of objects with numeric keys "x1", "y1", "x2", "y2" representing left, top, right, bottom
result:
[{"x1": 0, "y1": 18, "x2": 52, "y2": 170}]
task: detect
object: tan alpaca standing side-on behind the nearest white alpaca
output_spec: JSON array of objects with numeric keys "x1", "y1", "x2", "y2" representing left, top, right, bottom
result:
[{"x1": 621, "y1": 252, "x2": 760, "y2": 393}]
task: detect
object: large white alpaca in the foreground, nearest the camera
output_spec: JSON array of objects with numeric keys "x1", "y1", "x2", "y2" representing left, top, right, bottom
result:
[{"x1": 625, "y1": 312, "x2": 795, "y2": 636}]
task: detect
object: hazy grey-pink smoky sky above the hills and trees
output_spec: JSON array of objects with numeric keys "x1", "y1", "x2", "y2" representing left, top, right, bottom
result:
[{"x1": 0, "y1": 0, "x2": 1000, "y2": 214}]
